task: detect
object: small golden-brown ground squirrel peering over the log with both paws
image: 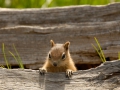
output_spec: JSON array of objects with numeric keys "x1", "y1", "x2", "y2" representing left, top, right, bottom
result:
[{"x1": 39, "y1": 40, "x2": 77, "y2": 78}]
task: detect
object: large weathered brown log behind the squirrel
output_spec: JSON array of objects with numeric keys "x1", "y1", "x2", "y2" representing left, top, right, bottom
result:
[{"x1": 0, "y1": 3, "x2": 120, "y2": 69}]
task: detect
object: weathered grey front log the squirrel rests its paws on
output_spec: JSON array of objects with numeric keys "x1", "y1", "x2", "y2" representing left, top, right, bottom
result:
[{"x1": 0, "y1": 60, "x2": 120, "y2": 90}]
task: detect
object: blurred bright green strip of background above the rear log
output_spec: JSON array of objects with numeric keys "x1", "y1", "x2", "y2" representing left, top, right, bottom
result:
[{"x1": 0, "y1": 0, "x2": 120, "y2": 8}]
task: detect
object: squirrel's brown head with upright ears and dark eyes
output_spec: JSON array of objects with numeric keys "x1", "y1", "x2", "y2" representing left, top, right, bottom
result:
[{"x1": 48, "y1": 40, "x2": 70, "y2": 67}]
